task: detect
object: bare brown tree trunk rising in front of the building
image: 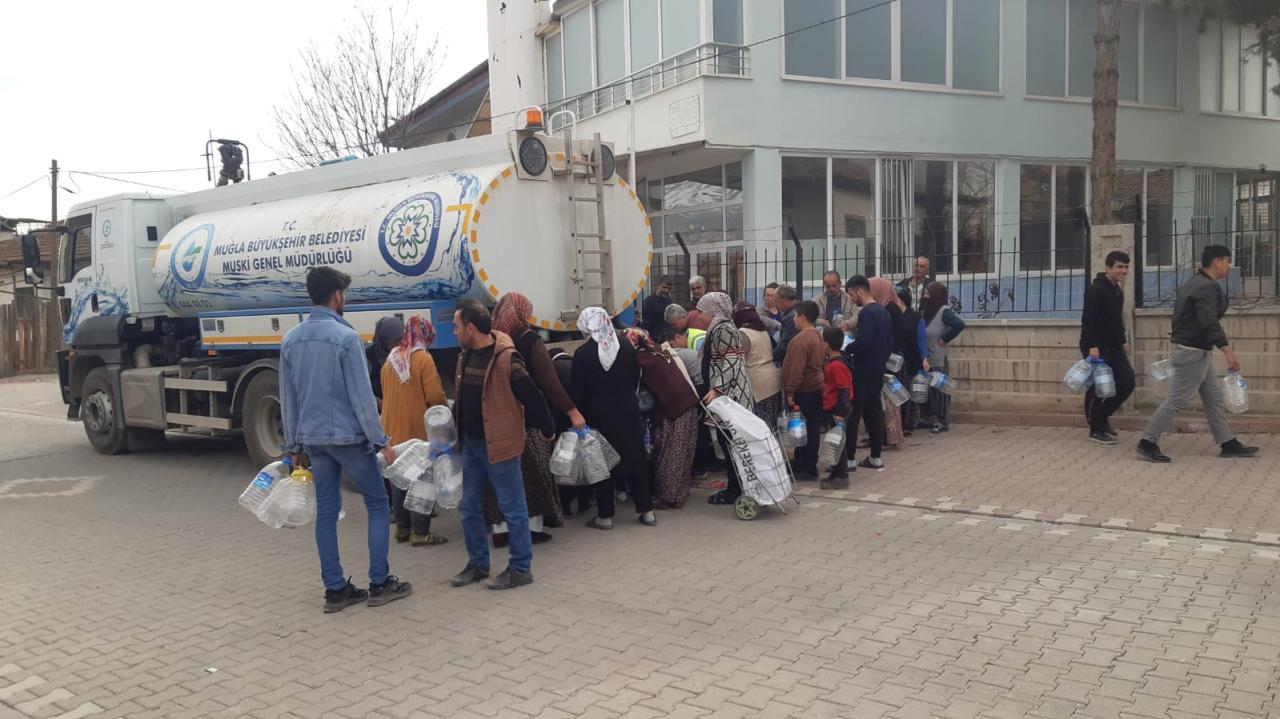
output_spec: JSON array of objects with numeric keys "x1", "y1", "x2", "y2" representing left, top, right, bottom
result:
[{"x1": 1089, "y1": 0, "x2": 1120, "y2": 225}]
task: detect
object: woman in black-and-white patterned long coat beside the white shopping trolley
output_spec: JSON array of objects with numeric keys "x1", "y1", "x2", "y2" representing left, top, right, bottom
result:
[{"x1": 698, "y1": 292, "x2": 755, "y2": 504}]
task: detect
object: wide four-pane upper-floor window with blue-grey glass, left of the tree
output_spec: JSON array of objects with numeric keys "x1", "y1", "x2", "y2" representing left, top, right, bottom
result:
[{"x1": 783, "y1": 0, "x2": 1001, "y2": 92}]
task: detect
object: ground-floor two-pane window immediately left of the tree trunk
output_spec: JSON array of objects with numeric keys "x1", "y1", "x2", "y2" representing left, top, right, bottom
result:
[{"x1": 1018, "y1": 165, "x2": 1089, "y2": 273}]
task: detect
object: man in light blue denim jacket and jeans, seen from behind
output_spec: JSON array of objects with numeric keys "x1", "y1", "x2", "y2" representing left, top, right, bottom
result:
[{"x1": 280, "y1": 267, "x2": 412, "y2": 613}]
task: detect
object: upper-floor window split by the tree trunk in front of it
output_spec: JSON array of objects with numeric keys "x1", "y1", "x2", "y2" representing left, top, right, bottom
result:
[{"x1": 1027, "y1": 0, "x2": 1178, "y2": 107}]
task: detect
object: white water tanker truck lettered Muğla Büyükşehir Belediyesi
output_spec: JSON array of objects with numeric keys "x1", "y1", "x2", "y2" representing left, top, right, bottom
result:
[{"x1": 23, "y1": 113, "x2": 653, "y2": 463}]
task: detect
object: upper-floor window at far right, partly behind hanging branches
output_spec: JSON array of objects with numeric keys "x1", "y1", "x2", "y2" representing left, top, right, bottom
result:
[{"x1": 1199, "y1": 20, "x2": 1280, "y2": 118}]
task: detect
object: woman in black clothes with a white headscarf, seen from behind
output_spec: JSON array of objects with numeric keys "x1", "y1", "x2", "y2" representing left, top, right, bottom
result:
[{"x1": 570, "y1": 307, "x2": 658, "y2": 530}]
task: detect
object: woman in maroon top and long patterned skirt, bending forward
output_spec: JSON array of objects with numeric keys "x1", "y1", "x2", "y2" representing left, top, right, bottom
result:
[{"x1": 623, "y1": 329, "x2": 698, "y2": 509}]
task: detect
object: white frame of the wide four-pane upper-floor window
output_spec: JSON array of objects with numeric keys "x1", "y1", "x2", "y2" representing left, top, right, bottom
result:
[{"x1": 778, "y1": 0, "x2": 1007, "y2": 97}]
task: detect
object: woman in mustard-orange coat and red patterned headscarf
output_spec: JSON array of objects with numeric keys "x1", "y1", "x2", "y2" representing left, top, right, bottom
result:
[{"x1": 379, "y1": 317, "x2": 449, "y2": 546}]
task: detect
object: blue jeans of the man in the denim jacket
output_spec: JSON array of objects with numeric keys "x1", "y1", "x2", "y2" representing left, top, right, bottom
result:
[{"x1": 305, "y1": 444, "x2": 390, "y2": 590}]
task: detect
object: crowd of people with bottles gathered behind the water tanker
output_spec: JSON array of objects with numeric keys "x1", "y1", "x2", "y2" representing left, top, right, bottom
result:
[{"x1": 280, "y1": 261, "x2": 964, "y2": 612}]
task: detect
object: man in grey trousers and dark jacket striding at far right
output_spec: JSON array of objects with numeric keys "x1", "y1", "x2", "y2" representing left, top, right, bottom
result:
[{"x1": 1138, "y1": 244, "x2": 1258, "y2": 463}]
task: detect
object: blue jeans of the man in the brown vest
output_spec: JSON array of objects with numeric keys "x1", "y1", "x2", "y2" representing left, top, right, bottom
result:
[{"x1": 458, "y1": 438, "x2": 534, "y2": 572}]
